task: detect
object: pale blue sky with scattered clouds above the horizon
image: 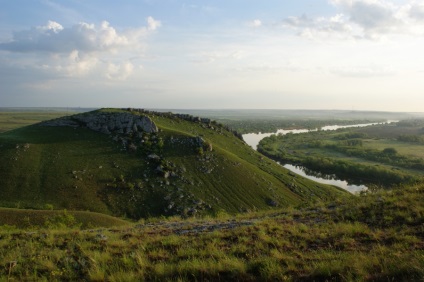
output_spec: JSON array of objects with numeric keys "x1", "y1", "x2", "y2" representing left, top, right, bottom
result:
[{"x1": 0, "y1": 0, "x2": 424, "y2": 112}]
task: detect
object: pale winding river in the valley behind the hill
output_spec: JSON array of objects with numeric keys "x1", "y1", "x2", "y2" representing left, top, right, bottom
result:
[{"x1": 243, "y1": 120, "x2": 397, "y2": 193}]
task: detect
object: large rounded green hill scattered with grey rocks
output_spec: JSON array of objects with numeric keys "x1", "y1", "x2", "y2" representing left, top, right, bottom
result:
[{"x1": 0, "y1": 109, "x2": 346, "y2": 219}]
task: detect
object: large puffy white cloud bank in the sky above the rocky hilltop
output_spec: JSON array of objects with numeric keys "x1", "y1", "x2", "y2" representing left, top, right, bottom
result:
[{"x1": 0, "y1": 17, "x2": 161, "y2": 80}]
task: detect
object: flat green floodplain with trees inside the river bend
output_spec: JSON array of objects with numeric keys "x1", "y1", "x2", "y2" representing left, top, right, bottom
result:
[{"x1": 258, "y1": 121, "x2": 424, "y2": 187}]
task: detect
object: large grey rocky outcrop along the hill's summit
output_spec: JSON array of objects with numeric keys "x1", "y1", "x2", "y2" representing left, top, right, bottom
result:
[{"x1": 42, "y1": 112, "x2": 158, "y2": 134}]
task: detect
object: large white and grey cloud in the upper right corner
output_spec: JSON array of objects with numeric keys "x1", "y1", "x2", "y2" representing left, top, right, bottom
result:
[{"x1": 283, "y1": 0, "x2": 424, "y2": 40}]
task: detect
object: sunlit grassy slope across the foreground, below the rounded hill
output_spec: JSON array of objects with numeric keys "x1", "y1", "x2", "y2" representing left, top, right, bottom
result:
[{"x1": 0, "y1": 186, "x2": 424, "y2": 281}]
